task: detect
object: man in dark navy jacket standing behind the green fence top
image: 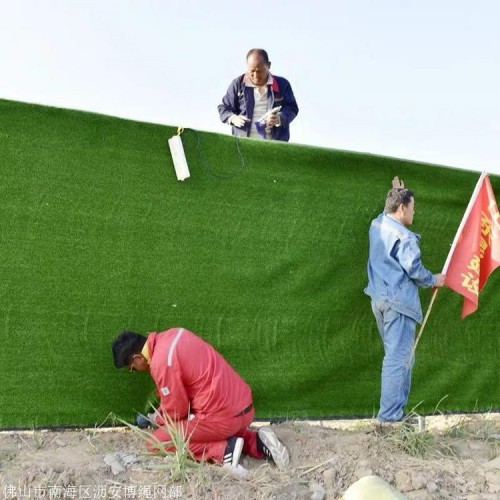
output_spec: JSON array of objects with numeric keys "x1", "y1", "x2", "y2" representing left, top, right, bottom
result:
[{"x1": 218, "y1": 49, "x2": 299, "y2": 141}]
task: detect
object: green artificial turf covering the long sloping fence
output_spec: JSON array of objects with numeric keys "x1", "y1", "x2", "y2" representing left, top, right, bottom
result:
[{"x1": 0, "y1": 100, "x2": 500, "y2": 427}]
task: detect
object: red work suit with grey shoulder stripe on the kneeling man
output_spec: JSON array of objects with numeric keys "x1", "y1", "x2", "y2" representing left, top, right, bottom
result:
[{"x1": 147, "y1": 328, "x2": 264, "y2": 463}]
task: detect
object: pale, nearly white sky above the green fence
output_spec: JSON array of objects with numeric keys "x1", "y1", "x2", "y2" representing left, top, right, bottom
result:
[{"x1": 0, "y1": 0, "x2": 500, "y2": 175}]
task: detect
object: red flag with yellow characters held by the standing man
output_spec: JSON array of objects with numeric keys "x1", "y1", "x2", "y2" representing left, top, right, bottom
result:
[{"x1": 443, "y1": 173, "x2": 500, "y2": 319}]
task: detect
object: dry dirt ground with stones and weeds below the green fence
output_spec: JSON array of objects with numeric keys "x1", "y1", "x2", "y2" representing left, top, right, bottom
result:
[{"x1": 0, "y1": 414, "x2": 500, "y2": 500}]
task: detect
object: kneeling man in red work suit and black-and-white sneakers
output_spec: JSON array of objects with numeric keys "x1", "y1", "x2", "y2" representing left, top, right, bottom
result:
[{"x1": 112, "y1": 328, "x2": 290, "y2": 468}]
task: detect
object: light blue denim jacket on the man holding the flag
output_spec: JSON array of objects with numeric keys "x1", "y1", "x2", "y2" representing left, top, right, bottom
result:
[{"x1": 365, "y1": 214, "x2": 436, "y2": 323}]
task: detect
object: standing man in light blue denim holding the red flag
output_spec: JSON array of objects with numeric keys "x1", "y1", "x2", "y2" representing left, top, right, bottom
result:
[{"x1": 365, "y1": 177, "x2": 445, "y2": 422}]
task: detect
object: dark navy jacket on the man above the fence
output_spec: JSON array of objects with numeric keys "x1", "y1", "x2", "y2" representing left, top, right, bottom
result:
[{"x1": 218, "y1": 75, "x2": 299, "y2": 141}]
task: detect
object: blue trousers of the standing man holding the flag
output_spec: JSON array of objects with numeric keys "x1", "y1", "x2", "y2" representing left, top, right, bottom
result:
[{"x1": 372, "y1": 300, "x2": 417, "y2": 422}]
